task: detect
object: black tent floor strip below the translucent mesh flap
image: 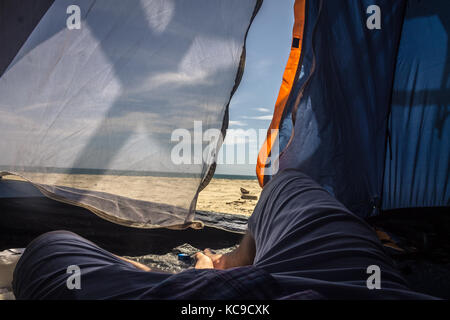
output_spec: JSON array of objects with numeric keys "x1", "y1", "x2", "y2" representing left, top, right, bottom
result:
[{"x1": 0, "y1": 197, "x2": 246, "y2": 256}]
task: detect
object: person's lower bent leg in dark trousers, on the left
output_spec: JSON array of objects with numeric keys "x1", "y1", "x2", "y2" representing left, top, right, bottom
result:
[{"x1": 13, "y1": 231, "x2": 170, "y2": 299}]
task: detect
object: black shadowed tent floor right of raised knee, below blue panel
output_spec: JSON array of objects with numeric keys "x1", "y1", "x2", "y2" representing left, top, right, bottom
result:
[{"x1": 369, "y1": 207, "x2": 450, "y2": 299}]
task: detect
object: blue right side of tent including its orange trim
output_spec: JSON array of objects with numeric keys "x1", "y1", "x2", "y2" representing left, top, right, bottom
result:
[{"x1": 258, "y1": 0, "x2": 450, "y2": 217}]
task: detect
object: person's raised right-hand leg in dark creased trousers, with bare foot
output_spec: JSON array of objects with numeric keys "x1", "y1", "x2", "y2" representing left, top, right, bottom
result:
[{"x1": 210, "y1": 170, "x2": 436, "y2": 299}]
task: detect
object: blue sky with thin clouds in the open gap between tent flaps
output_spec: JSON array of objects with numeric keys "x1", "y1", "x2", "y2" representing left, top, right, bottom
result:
[{"x1": 216, "y1": 0, "x2": 294, "y2": 176}]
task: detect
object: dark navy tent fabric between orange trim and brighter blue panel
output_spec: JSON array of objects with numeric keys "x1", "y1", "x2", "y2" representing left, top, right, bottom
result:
[{"x1": 279, "y1": 0, "x2": 405, "y2": 217}]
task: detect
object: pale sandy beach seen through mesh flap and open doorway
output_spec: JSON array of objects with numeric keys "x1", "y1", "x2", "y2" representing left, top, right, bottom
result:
[{"x1": 3, "y1": 173, "x2": 261, "y2": 215}]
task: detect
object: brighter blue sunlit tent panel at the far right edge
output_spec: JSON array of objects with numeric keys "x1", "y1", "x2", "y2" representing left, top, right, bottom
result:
[{"x1": 383, "y1": 0, "x2": 450, "y2": 209}]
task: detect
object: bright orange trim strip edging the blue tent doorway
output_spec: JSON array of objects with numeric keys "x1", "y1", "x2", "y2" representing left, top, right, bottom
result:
[{"x1": 256, "y1": 0, "x2": 306, "y2": 187}]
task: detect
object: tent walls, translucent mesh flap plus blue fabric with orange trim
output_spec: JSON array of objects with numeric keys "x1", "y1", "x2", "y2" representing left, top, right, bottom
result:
[{"x1": 0, "y1": 0, "x2": 450, "y2": 235}]
